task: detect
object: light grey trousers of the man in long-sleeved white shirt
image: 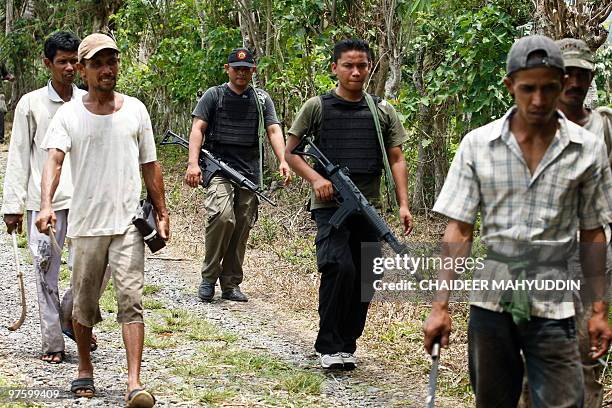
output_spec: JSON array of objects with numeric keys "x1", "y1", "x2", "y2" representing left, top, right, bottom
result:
[{"x1": 27, "y1": 210, "x2": 72, "y2": 354}]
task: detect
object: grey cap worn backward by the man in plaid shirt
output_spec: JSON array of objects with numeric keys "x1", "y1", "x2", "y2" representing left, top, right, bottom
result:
[{"x1": 506, "y1": 35, "x2": 565, "y2": 76}]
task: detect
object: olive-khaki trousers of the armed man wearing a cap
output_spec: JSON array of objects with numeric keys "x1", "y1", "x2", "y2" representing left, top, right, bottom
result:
[{"x1": 202, "y1": 176, "x2": 259, "y2": 291}]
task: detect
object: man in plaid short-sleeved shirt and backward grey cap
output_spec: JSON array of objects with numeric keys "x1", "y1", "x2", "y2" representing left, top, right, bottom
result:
[{"x1": 423, "y1": 36, "x2": 612, "y2": 407}]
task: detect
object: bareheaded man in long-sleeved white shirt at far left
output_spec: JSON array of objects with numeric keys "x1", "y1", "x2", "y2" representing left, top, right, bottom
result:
[{"x1": 2, "y1": 31, "x2": 89, "y2": 364}]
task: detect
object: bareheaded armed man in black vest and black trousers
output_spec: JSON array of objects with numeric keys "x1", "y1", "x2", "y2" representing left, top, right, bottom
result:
[{"x1": 285, "y1": 39, "x2": 412, "y2": 369}]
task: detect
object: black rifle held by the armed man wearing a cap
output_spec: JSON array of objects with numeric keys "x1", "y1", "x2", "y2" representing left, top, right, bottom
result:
[{"x1": 160, "y1": 130, "x2": 276, "y2": 206}]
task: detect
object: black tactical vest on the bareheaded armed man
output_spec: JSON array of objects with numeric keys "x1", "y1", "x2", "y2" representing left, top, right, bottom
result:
[{"x1": 318, "y1": 93, "x2": 383, "y2": 174}]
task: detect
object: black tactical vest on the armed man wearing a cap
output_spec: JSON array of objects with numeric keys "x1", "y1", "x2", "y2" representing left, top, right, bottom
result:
[{"x1": 207, "y1": 86, "x2": 259, "y2": 147}]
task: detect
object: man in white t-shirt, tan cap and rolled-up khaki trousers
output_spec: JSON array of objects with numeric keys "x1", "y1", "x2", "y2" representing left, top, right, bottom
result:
[{"x1": 36, "y1": 34, "x2": 169, "y2": 407}]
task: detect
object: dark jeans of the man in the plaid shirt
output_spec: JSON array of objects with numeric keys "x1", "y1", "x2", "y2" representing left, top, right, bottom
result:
[{"x1": 468, "y1": 306, "x2": 584, "y2": 408}]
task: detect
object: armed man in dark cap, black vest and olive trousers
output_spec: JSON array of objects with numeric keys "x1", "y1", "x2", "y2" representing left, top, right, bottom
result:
[{"x1": 185, "y1": 48, "x2": 290, "y2": 302}]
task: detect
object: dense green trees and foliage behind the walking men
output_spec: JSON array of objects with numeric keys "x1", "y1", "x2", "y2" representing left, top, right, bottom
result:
[{"x1": 0, "y1": 0, "x2": 612, "y2": 209}]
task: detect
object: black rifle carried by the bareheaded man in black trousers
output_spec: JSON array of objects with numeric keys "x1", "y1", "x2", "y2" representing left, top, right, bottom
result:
[{"x1": 291, "y1": 137, "x2": 408, "y2": 254}]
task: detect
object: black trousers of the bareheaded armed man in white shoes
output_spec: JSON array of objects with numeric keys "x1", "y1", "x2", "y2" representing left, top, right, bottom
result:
[{"x1": 312, "y1": 208, "x2": 380, "y2": 354}]
